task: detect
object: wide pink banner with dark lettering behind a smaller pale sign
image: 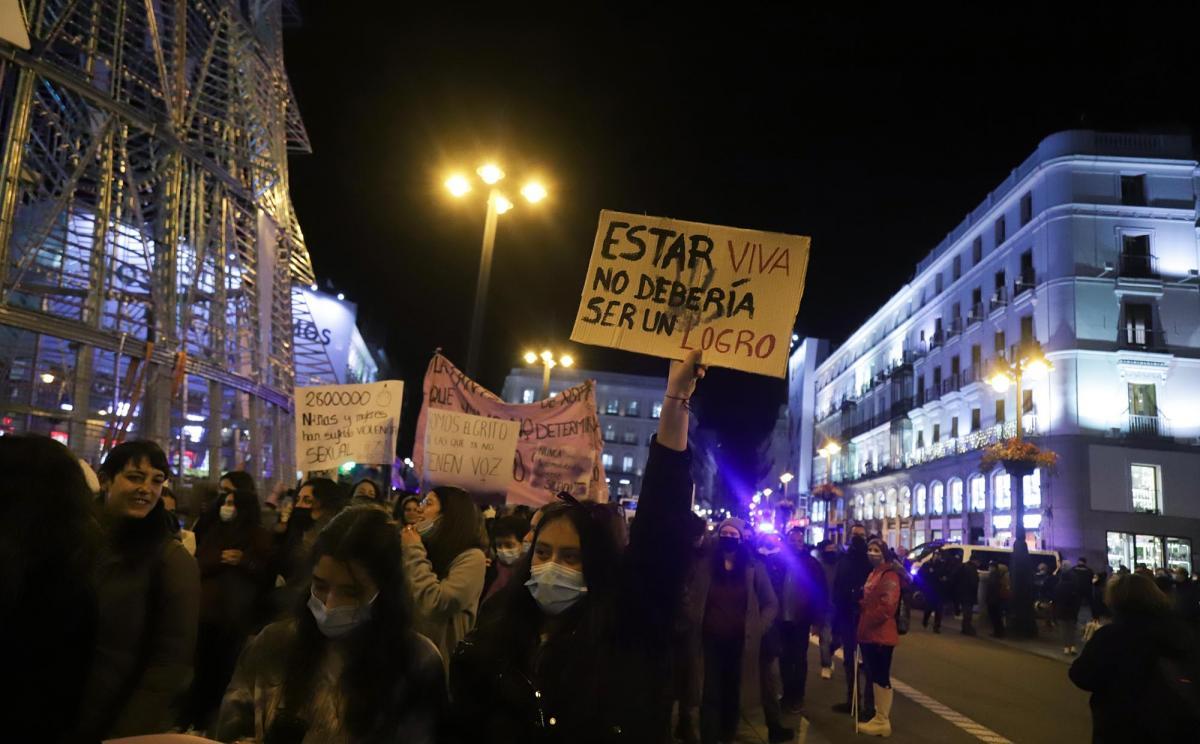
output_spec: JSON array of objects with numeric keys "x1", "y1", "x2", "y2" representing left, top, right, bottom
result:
[{"x1": 413, "y1": 354, "x2": 608, "y2": 506}]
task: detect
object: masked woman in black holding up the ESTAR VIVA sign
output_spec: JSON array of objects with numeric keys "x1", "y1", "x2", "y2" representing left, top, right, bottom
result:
[{"x1": 450, "y1": 352, "x2": 704, "y2": 744}]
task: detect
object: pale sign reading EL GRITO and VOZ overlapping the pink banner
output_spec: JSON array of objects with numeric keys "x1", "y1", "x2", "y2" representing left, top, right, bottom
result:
[{"x1": 421, "y1": 409, "x2": 521, "y2": 493}]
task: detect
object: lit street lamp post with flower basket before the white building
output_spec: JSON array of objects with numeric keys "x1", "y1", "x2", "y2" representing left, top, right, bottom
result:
[{"x1": 988, "y1": 342, "x2": 1054, "y2": 637}]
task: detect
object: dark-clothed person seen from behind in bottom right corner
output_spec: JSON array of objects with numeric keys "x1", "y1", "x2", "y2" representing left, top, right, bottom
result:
[{"x1": 1069, "y1": 574, "x2": 1200, "y2": 744}]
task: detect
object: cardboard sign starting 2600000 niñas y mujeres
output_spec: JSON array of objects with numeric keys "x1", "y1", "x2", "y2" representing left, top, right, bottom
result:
[{"x1": 296, "y1": 380, "x2": 404, "y2": 470}]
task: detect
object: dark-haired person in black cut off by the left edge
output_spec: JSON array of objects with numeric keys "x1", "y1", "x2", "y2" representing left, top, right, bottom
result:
[{"x1": 0, "y1": 434, "x2": 101, "y2": 742}]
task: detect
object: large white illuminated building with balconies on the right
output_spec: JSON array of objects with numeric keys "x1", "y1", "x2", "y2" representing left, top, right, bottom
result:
[{"x1": 792, "y1": 131, "x2": 1200, "y2": 570}]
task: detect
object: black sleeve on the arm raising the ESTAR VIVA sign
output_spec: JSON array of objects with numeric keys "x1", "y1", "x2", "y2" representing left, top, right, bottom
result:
[{"x1": 618, "y1": 438, "x2": 692, "y2": 643}]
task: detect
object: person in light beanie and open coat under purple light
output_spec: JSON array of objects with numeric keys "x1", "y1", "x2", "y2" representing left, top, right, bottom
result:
[{"x1": 686, "y1": 517, "x2": 792, "y2": 744}]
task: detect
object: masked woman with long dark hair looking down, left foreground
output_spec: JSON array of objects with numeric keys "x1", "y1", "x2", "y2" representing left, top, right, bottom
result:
[{"x1": 215, "y1": 508, "x2": 445, "y2": 744}]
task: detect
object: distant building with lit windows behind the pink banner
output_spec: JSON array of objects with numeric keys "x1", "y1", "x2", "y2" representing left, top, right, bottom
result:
[{"x1": 502, "y1": 366, "x2": 667, "y2": 500}]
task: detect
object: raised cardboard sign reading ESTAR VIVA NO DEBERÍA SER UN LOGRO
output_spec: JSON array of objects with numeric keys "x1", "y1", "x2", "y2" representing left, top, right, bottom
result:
[{"x1": 571, "y1": 210, "x2": 810, "y2": 377}]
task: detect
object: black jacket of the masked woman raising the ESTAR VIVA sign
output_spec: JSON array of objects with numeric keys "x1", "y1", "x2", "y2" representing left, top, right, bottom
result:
[{"x1": 450, "y1": 442, "x2": 692, "y2": 744}]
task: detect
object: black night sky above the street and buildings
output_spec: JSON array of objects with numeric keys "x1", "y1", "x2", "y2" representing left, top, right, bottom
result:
[{"x1": 284, "y1": 7, "x2": 1200, "y2": 494}]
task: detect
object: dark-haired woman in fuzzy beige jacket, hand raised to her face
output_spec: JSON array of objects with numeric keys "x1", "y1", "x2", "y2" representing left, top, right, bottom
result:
[{"x1": 400, "y1": 486, "x2": 487, "y2": 661}]
